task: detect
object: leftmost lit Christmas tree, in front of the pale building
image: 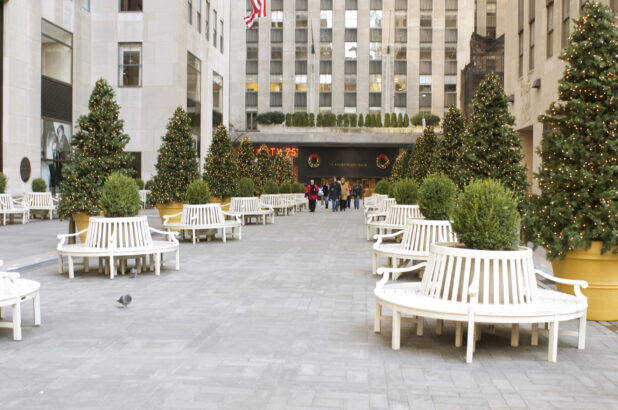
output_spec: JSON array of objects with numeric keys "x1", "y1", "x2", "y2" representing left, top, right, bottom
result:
[{"x1": 58, "y1": 79, "x2": 132, "y2": 218}]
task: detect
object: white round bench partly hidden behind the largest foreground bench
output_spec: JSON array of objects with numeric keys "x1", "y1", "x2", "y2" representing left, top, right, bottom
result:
[{"x1": 372, "y1": 218, "x2": 457, "y2": 279}]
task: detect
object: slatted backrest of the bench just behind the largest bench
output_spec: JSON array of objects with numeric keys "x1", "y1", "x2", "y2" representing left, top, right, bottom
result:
[{"x1": 401, "y1": 218, "x2": 457, "y2": 254}]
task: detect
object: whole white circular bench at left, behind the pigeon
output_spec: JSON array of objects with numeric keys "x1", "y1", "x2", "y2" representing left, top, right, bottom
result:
[{"x1": 56, "y1": 216, "x2": 180, "y2": 279}]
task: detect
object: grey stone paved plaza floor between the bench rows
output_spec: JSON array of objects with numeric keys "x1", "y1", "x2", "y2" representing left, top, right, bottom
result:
[{"x1": 0, "y1": 206, "x2": 618, "y2": 410}]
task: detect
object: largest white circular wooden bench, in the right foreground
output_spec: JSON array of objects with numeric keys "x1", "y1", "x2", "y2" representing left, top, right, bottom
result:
[{"x1": 374, "y1": 244, "x2": 588, "y2": 363}]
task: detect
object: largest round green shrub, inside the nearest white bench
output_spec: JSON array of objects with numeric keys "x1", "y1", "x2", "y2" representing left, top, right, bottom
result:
[{"x1": 451, "y1": 179, "x2": 520, "y2": 250}]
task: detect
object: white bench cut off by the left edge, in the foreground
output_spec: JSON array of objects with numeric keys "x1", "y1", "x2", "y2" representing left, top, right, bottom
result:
[{"x1": 0, "y1": 261, "x2": 41, "y2": 340}]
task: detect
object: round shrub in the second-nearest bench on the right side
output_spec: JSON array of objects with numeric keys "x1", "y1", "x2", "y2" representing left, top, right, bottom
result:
[{"x1": 418, "y1": 174, "x2": 457, "y2": 220}]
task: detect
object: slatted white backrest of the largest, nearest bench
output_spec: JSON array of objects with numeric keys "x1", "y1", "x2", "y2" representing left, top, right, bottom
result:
[{"x1": 421, "y1": 243, "x2": 537, "y2": 306}]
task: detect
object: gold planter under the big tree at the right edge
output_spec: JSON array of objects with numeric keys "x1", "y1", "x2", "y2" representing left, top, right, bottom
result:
[{"x1": 552, "y1": 241, "x2": 618, "y2": 320}]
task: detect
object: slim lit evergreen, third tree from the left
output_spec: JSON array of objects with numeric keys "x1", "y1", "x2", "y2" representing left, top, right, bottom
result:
[{"x1": 204, "y1": 125, "x2": 239, "y2": 199}]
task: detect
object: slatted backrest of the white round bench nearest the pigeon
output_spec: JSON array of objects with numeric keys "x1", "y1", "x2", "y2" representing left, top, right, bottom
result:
[{"x1": 86, "y1": 216, "x2": 152, "y2": 249}]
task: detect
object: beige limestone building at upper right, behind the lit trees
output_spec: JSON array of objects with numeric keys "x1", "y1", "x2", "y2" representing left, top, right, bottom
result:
[{"x1": 504, "y1": 0, "x2": 618, "y2": 192}]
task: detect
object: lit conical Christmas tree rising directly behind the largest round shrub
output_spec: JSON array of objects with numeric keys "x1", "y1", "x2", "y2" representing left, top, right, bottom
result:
[{"x1": 455, "y1": 72, "x2": 529, "y2": 202}]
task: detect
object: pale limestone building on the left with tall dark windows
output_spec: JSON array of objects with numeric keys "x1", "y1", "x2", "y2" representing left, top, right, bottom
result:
[{"x1": 0, "y1": 0, "x2": 230, "y2": 193}]
